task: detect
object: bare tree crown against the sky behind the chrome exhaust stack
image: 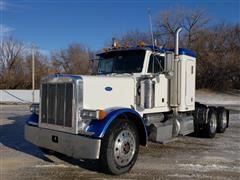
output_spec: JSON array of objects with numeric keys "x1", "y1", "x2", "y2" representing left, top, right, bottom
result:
[{"x1": 155, "y1": 8, "x2": 209, "y2": 48}]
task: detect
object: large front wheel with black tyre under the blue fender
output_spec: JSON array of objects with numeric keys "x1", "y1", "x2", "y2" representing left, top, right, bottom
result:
[{"x1": 100, "y1": 119, "x2": 139, "y2": 174}]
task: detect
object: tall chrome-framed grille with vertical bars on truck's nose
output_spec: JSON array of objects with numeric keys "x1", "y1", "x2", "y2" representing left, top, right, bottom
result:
[{"x1": 41, "y1": 83, "x2": 73, "y2": 127}]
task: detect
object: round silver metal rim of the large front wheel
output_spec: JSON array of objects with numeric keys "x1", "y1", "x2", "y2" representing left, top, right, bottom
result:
[{"x1": 114, "y1": 130, "x2": 136, "y2": 166}]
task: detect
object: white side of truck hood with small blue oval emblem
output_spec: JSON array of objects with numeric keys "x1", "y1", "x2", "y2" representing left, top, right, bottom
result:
[{"x1": 81, "y1": 76, "x2": 135, "y2": 110}]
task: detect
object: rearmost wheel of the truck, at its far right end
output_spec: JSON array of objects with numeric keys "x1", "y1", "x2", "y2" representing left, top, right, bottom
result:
[{"x1": 217, "y1": 108, "x2": 228, "y2": 133}]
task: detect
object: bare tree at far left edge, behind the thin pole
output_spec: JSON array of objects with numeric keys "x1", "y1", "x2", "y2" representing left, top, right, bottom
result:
[{"x1": 0, "y1": 37, "x2": 51, "y2": 89}]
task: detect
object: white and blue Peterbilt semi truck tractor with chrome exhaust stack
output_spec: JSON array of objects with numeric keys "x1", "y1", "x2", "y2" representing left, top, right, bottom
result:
[{"x1": 25, "y1": 28, "x2": 229, "y2": 174}]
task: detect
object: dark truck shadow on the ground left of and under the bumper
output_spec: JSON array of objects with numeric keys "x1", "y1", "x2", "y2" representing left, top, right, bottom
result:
[{"x1": 0, "y1": 115, "x2": 100, "y2": 171}]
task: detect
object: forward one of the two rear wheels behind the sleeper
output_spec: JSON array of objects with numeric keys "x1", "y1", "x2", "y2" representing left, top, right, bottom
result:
[{"x1": 205, "y1": 108, "x2": 217, "y2": 138}]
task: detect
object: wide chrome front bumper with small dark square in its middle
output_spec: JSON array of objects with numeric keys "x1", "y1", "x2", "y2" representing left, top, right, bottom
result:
[{"x1": 25, "y1": 124, "x2": 101, "y2": 159}]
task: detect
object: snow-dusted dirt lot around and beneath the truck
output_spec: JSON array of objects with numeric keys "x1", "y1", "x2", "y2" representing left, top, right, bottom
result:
[{"x1": 0, "y1": 92, "x2": 240, "y2": 180}]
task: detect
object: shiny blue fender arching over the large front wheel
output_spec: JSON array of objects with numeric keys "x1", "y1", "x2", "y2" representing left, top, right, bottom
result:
[{"x1": 87, "y1": 108, "x2": 147, "y2": 146}]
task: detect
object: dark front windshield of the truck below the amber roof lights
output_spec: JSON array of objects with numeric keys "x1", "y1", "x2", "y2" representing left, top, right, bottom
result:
[{"x1": 97, "y1": 50, "x2": 145, "y2": 74}]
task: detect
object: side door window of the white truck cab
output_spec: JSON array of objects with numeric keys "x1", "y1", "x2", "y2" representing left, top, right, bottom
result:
[{"x1": 148, "y1": 54, "x2": 164, "y2": 73}]
